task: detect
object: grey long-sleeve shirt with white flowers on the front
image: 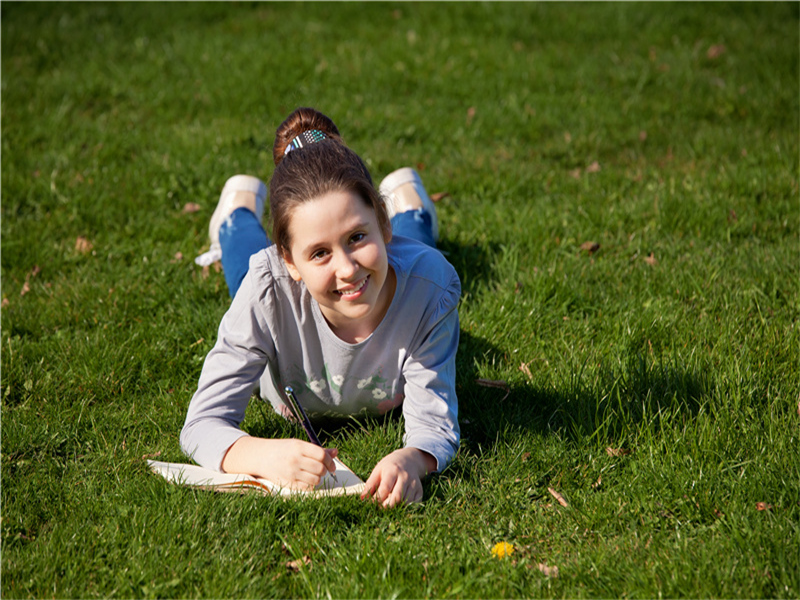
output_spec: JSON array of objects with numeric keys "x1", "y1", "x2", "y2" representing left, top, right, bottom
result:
[{"x1": 181, "y1": 236, "x2": 461, "y2": 471}]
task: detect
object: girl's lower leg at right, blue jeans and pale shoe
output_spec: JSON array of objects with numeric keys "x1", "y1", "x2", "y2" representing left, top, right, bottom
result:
[{"x1": 380, "y1": 167, "x2": 439, "y2": 248}]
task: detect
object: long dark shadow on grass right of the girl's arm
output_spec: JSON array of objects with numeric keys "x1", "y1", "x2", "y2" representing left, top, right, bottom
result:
[{"x1": 458, "y1": 332, "x2": 709, "y2": 454}]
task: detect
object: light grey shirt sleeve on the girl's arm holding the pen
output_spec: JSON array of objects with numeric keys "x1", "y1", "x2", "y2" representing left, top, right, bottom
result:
[{"x1": 180, "y1": 266, "x2": 275, "y2": 471}]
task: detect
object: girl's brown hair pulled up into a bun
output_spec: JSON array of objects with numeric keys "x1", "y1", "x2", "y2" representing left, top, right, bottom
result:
[{"x1": 269, "y1": 108, "x2": 391, "y2": 255}]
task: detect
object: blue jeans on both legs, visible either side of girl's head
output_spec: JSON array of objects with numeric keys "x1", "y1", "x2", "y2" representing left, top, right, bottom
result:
[{"x1": 219, "y1": 208, "x2": 436, "y2": 298}]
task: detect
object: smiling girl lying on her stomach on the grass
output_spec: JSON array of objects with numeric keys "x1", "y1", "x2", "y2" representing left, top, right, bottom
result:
[{"x1": 181, "y1": 108, "x2": 461, "y2": 507}]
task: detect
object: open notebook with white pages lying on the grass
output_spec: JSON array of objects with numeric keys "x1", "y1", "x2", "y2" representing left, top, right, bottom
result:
[{"x1": 147, "y1": 459, "x2": 364, "y2": 498}]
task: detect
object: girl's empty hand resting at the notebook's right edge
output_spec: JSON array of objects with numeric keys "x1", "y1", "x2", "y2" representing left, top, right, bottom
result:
[{"x1": 361, "y1": 448, "x2": 436, "y2": 508}]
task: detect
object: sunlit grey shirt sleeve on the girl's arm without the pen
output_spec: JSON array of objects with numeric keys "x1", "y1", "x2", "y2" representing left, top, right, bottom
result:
[{"x1": 403, "y1": 272, "x2": 461, "y2": 471}]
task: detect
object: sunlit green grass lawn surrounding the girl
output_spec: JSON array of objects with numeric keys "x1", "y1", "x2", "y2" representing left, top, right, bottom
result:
[{"x1": 0, "y1": 2, "x2": 800, "y2": 598}]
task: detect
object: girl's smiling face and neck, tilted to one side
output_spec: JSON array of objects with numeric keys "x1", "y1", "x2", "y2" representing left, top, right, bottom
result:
[{"x1": 284, "y1": 192, "x2": 396, "y2": 343}]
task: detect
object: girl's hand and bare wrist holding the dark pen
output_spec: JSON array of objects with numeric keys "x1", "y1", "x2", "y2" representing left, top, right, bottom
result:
[{"x1": 222, "y1": 436, "x2": 339, "y2": 490}]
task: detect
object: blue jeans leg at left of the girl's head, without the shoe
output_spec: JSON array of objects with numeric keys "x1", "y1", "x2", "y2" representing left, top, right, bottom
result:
[{"x1": 219, "y1": 207, "x2": 272, "y2": 298}]
